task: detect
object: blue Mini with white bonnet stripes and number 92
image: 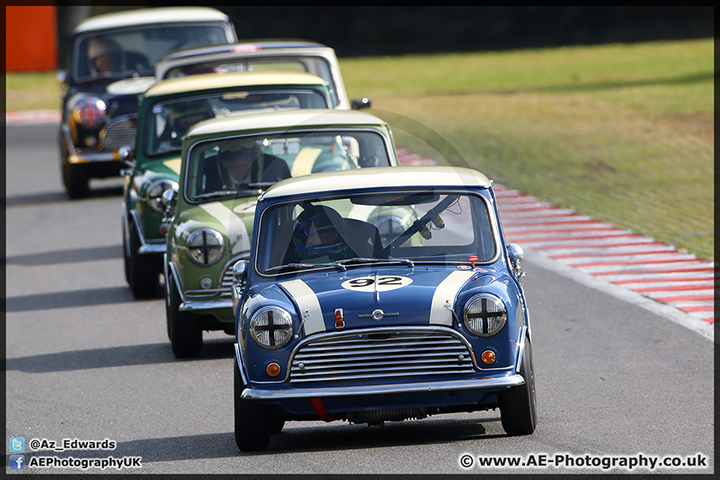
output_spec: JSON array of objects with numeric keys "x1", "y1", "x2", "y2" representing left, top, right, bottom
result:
[{"x1": 233, "y1": 167, "x2": 536, "y2": 450}]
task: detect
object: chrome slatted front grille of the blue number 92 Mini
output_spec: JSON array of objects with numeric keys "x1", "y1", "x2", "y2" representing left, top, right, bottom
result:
[{"x1": 290, "y1": 327, "x2": 475, "y2": 384}]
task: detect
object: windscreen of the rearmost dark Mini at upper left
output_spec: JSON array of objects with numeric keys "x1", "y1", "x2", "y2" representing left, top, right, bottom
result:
[{"x1": 73, "y1": 24, "x2": 227, "y2": 80}]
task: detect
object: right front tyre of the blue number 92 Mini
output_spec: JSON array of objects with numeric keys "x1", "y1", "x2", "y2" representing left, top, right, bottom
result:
[{"x1": 499, "y1": 339, "x2": 537, "y2": 436}]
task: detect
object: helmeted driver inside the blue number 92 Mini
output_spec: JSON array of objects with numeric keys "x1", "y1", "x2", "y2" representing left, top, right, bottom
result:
[{"x1": 293, "y1": 205, "x2": 351, "y2": 262}]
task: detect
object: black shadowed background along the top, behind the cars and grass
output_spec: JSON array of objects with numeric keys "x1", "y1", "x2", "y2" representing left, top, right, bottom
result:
[{"x1": 58, "y1": 4, "x2": 715, "y2": 68}]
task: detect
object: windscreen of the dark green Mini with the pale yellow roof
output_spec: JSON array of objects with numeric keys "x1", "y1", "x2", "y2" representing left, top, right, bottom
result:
[{"x1": 143, "y1": 88, "x2": 330, "y2": 157}]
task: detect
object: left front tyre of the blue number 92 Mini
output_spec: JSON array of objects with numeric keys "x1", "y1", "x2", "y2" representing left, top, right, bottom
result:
[{"x1": 233, "y1": 359, "x2": 272, "y2": 452}]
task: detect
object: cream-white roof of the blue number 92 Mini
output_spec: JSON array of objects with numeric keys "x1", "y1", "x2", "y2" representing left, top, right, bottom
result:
[{"x1": 262, "y1": 166, "x2": 493, "y2": 199}]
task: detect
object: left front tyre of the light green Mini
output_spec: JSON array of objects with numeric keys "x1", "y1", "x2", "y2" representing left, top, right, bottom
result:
[{"x1": 165, "y1": 268, "x2": 202, "y2": 358}]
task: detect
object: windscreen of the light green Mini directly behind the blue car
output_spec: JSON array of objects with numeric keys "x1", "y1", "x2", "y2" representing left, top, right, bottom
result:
[{"x1": 185, "y1": 129, "x2": 390, "y2": 202}]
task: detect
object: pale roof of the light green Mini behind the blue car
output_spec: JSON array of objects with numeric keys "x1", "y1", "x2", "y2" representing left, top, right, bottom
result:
[{"x1": 187, "y1": 109, "x2": 386, "y2": 137}]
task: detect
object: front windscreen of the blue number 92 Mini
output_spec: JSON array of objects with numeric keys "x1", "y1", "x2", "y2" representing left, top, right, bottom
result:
[{"x1": 257, "y1": 189, "x2": 497, "y2": 275}]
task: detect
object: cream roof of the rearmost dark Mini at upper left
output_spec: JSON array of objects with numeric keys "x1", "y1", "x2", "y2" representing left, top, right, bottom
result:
[{"x1": 75, "y1": 7, "x2": 228, "y2": 33}]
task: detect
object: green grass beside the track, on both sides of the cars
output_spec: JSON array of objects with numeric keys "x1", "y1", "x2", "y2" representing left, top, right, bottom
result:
[{"x1": 6, "y1": 39, "x2": 715, "y2": 260}]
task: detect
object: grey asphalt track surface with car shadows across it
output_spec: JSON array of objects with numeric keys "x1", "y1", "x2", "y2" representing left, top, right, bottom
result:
[{"x1": 5, "y1": 121, "x2": 715, "y2": 474}]
